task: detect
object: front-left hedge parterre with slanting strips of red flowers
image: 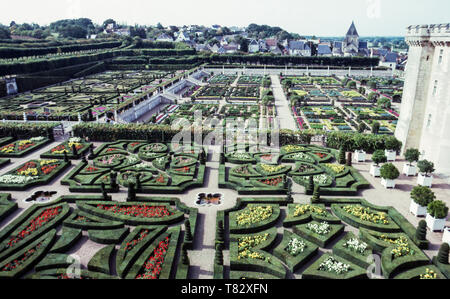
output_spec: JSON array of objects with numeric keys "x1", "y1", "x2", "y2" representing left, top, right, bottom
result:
[{"x1": 0, "y1": 196, "x2": 197, "y2": 279}]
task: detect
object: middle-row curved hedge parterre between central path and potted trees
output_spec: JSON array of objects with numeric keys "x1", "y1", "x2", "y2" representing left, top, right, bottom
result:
[{"x1": 219, "y1": 145, "x2": 369, "y2": 195}]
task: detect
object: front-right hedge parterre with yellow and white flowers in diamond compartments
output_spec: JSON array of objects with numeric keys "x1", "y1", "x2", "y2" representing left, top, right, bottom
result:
[{"x1": 214, "y1": 198, "x2": 434, "y2": 279}]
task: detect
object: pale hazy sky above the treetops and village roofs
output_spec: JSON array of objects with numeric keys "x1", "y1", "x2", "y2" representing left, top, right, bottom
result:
[{"x1": 0, "y1": 0, "x2": 450, "y2": 36}]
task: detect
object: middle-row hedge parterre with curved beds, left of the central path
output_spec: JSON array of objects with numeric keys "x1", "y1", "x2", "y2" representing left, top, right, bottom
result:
[{"x1": 61, "y1": 140, "x2": 205, "y2": 193}]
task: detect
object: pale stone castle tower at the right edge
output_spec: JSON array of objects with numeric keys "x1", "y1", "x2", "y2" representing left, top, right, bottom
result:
[{"x1": 395, "y1": 24, "x2": 450, "y2": 174}]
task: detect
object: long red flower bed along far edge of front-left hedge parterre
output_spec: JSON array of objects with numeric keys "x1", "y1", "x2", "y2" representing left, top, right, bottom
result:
[{"x1": 97, "y1": 204, "x2": 173, "y2": 218}]
